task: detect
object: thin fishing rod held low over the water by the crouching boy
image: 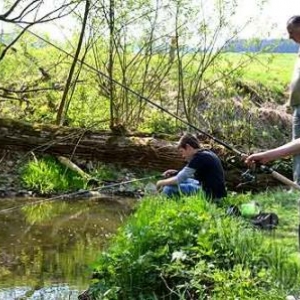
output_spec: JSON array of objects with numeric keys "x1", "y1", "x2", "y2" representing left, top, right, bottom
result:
[{"x1": 0, "y1": 174, "x2": 163, "y2": 214}]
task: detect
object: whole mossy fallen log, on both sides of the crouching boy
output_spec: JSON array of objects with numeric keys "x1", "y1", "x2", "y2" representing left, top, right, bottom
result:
[{"x1": 0, "y1": 119, "x2": 292, "y2": 191}]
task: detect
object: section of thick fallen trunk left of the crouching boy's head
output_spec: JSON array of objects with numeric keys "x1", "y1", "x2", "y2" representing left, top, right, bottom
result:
[{"x1": 0, "y1": 119, "x2": 188, "y2": 171}]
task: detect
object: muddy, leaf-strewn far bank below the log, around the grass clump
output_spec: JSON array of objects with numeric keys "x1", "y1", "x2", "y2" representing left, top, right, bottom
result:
[{"x1": 0, "y1": 150, "x2": 156, "y2": 200}]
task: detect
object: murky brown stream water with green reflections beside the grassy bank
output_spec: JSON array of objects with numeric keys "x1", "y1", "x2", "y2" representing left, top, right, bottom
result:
[{"x1": 0, "y1": 198, "x2": 134, "y2": 300}]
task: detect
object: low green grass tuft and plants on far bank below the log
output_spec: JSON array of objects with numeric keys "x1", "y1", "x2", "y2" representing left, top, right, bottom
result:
[{"x1": 19, "y1": 156, "x2": 159, "y2": 196}]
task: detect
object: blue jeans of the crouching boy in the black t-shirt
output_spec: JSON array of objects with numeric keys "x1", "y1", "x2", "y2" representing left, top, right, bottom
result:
[{"x1": 162, "y1": 178, "x2": 201, "y2": 197}]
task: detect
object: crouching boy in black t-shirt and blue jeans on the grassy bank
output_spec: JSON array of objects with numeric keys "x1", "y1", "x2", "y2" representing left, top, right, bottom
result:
[{"x1": 156, "y1": 134, "x2": 227, "y2": 203}]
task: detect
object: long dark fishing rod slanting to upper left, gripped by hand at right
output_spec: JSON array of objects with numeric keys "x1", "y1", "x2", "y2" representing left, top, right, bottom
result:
[{"x1": 16, "y1": 24, "x2": 300, "y2": 190}]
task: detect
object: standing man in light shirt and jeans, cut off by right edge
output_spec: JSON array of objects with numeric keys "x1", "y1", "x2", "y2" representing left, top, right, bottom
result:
[{"x1": 287, "y1": 15, "x2": 300, "y2": 185}]
